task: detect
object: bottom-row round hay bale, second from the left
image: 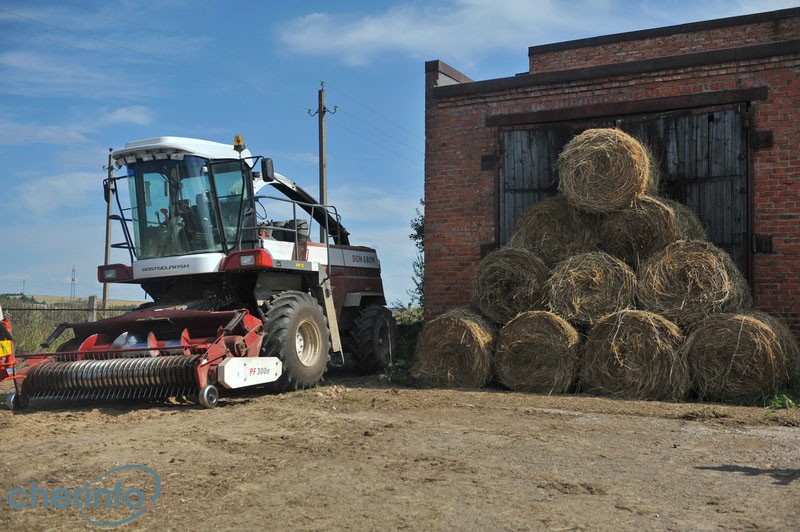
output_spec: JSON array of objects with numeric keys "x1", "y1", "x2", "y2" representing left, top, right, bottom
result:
[{"x1": 495, "y1": 311, "x2": 580, "y2": 394}]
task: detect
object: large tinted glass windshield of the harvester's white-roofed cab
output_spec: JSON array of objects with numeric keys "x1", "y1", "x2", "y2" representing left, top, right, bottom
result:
[{"x1": 128, "y1": 155, "x2": 250, "y2": 259}]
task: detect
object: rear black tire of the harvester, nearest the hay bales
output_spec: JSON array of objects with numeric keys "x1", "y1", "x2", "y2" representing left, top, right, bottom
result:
[{"x1": 350, "y1": 306, "x2": 397, "y2": 373}]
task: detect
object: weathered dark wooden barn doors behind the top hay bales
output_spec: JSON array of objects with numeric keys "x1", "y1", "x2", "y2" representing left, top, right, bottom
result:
[{"x1": 498, "y1": 104, "x2": 749, "y2": 274}]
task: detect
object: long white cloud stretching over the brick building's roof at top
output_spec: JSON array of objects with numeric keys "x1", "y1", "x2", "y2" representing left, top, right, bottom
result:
[{"x1": 279, "y1": 0, "x2": 796, "y2": 65}]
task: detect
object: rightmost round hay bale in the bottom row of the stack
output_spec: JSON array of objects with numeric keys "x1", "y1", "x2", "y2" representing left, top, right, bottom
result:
[{"x1": 683, "y1": 312, "x2": 798, "y2": 401}]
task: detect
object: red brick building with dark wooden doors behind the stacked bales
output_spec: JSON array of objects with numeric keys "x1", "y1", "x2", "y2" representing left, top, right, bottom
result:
[{"x1": 425, "y1": 8, "x2": 800, "y2": 334}]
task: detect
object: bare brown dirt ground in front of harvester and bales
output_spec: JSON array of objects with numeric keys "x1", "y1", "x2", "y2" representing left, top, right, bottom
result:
[{"x1": 0, "y1": 372, "x2": 800, "y2": 531}]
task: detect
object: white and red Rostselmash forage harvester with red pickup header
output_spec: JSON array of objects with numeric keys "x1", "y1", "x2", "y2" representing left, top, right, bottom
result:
[{"x1": 6, "y1": 137, "x2": 396, "y2": 407}]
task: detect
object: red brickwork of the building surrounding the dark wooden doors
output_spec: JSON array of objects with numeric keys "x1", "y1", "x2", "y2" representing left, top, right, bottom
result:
[{"x1": 425, "y1": 8, "x2": 800, "y2": 333}]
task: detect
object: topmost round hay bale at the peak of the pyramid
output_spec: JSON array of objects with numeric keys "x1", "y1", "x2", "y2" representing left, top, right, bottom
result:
[{"x1": 558, "y1": 128, "x2": 650, "y2": 213}]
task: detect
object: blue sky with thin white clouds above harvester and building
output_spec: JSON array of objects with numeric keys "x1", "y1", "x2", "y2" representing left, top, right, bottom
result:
[{"x1": 0, "y1": 0, "x2": 798, "y2": 301}]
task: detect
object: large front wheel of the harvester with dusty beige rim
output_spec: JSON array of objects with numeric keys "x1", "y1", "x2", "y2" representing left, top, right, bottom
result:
[{"x1": 261, "y1": 291, "x2": 331, "y2": 392}]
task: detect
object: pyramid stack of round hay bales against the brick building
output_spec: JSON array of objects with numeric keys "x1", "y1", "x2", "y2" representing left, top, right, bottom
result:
[{"x1": 413, "y1": 129, "x2": 800, "y2": 401}]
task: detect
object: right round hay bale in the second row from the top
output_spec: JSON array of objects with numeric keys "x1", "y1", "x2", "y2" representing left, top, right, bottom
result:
[{"x1": 598, "y1": 196, "x2": 681, "y2": 268}]
